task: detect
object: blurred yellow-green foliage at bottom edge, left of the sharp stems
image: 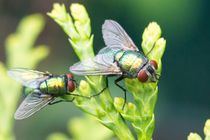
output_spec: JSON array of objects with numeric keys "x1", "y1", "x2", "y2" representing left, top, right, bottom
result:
[{"x1": 47, "y1": 116, "x2": 114, "y2": 140}]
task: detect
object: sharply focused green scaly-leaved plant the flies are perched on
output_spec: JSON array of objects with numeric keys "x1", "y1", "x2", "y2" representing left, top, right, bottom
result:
[{"x1": 48, "y1": 3, "x2": 166, "y2": 140}]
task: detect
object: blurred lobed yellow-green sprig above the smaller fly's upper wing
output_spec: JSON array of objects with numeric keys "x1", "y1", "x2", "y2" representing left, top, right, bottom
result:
[{"x1": 6, "y1": 14, "x2": 49, "y2": 69}]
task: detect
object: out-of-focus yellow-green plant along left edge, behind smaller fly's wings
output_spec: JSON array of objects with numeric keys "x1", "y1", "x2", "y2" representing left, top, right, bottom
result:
[{"x1": 0, "y1": 14, "x2": 48, "y2": 140}]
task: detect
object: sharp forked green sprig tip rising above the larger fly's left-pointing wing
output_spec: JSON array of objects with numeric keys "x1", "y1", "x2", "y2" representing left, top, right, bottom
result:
[{"x1": 47, "y1": 3, "x2": 94, "y2": 60}]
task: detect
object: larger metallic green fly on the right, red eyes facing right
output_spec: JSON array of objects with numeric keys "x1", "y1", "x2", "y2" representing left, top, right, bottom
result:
[{"x1": 69, "y1": 20, "x2": 159, "y2": 107}]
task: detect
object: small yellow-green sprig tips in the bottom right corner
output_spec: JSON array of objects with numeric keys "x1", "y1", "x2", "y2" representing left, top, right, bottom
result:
[{"x1": 187, "y1": 119, "x2": 210, "y2": 140}]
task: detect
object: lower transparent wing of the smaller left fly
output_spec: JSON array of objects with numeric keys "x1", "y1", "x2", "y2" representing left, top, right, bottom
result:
[{"x1": 14, "y1": 93, "x2": 55, "y2": 120}]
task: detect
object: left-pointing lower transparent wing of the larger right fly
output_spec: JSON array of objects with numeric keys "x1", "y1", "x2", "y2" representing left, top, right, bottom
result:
[{"x1": 70, "y1": 47, "x2": 122, "y2": 75}]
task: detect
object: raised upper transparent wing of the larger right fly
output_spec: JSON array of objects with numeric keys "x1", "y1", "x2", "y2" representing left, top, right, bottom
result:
[{"x1": 102, "y1": 20, "x2": 139, "y2": 51}]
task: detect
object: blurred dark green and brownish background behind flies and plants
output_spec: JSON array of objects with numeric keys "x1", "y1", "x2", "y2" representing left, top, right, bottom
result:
[{"x1": 0, "y1": 0, "x2": 210, "y2": 140}]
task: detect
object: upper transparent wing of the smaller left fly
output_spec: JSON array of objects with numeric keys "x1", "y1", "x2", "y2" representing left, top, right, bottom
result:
[{"x1": 8, "y1": 69, "x2": 51, "y2": 88}]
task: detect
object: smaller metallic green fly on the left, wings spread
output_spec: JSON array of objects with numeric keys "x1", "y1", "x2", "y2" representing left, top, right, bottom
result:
[{"x1": 8, "y1": 69, "x2": 88, "y2": 120}]
